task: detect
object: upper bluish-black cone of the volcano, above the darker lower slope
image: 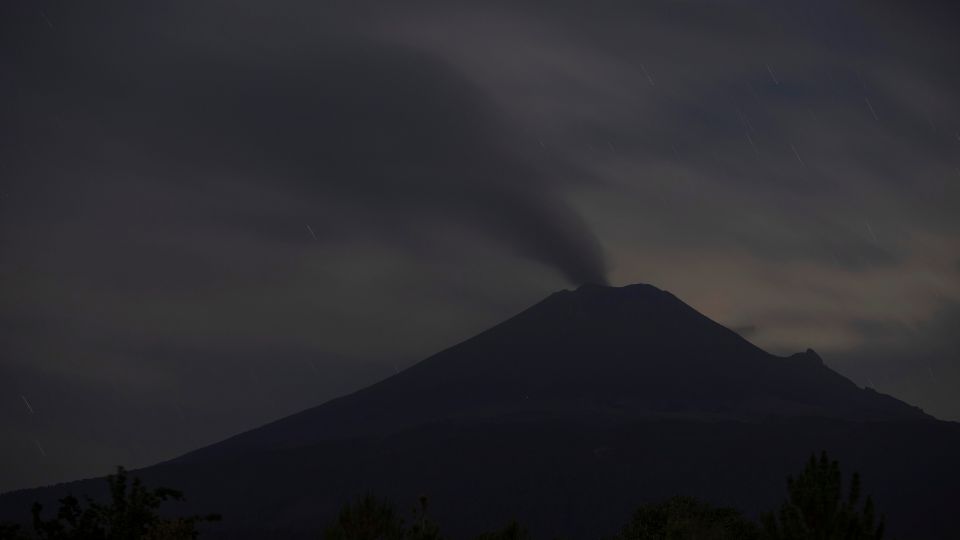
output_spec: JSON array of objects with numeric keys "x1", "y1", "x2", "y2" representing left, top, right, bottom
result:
[{"x1": 180, "y1": 284, "x2": 930, "y2": 462}]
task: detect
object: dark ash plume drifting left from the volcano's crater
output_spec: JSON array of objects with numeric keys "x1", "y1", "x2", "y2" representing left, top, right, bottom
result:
[{"x1": 4, "y1": 3, "x2": 606, "y2": 284}]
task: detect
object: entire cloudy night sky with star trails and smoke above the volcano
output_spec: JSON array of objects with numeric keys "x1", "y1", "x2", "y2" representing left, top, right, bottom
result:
[{"x1": 0, "y1": 0, "x2": 960, "y2": 490}]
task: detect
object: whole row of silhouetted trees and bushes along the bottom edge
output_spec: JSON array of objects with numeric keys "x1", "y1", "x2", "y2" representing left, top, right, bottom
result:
[{"x1": 0, "y1": 452, "x2": 884, "y2": 540}]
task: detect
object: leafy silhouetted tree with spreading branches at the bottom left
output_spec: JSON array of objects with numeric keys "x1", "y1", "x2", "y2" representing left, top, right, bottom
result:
[{"x1": 32, "y1": 467, "x2": 220, "y2": 540}]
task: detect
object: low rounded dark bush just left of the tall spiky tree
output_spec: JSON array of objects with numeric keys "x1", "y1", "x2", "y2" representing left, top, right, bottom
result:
[{"x1": 616, "y1": 496, "x2": 758, "y2": 540}]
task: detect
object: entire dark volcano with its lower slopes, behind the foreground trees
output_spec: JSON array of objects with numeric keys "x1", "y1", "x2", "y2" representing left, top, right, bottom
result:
[{"x1": 0, "y1": 285, "x2": 960, "y2": 538}]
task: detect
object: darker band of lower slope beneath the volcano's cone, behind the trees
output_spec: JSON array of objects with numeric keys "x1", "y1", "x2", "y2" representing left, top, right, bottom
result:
[{"x1": 0, "y1": 419, "x2": 960, "y2": 539}]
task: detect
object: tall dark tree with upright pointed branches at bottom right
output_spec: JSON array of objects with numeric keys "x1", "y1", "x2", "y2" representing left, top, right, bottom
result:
[{"x1": 761, "y1": 452, "x2": 884, "y2": 540}]
